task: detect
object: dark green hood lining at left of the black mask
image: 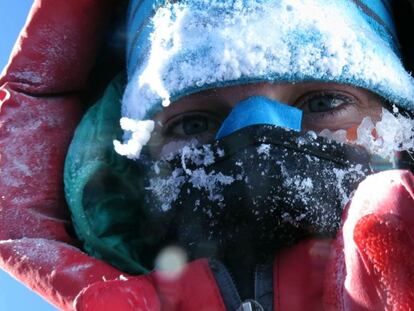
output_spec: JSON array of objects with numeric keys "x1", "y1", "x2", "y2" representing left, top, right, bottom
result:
[{"x1": 64, "y1": 74, "x2": 159, "y2": 274}]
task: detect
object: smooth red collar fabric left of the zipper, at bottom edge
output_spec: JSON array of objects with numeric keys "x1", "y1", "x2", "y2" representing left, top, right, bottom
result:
[{"x1": 76, "y1": 260, "x2": 226, "y2": 311}]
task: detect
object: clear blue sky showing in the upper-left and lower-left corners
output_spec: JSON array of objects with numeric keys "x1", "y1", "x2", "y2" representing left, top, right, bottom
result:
[{"x1": 0, "y1": 0, "x2": 56, "y2": 311}]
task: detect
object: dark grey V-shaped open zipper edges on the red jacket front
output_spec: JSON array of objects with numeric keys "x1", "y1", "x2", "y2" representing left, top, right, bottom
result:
[{"x1": 209, "y1": 259, "x2": 273, "y2": 311}]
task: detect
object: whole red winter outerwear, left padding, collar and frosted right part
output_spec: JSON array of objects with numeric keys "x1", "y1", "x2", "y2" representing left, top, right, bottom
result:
[{"x1": 0, "y1": 0, "x2": 414, "y2": 311}]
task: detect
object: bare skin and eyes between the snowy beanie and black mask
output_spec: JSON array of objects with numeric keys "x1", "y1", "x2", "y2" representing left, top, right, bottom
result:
[{"x1": 149, "y1": 82, "x2": 382, "y2": 158}]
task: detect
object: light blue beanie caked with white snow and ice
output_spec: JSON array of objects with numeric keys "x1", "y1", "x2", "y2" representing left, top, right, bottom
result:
[{"x1": 114, "y1": 0, "x2": 414, "y2": 159}]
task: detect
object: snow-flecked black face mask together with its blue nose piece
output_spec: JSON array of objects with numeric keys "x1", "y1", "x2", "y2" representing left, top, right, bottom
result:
[{"x1": 142, "y1": 97, "x2": 372, "y2": 260}]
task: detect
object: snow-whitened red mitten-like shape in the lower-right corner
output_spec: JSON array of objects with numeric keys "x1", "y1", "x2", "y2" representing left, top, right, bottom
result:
[{"x1": 325, "y1": 171, "x2": 414, "y2": 311}]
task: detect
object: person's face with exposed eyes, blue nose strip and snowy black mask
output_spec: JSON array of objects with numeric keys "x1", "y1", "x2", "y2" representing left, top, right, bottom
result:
[{"x1": 145, "y1": 82, "x2": 382, "y2": 258}]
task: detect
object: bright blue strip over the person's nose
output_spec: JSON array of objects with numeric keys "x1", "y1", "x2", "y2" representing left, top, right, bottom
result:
[{"x1": 216, "y1": 96, "x2": 302, "y2": 139}]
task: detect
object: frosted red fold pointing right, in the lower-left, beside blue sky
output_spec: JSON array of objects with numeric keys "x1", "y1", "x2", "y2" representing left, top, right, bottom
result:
[{"x1": 0, "y1": 239, "x2": 121, "y2": 310}]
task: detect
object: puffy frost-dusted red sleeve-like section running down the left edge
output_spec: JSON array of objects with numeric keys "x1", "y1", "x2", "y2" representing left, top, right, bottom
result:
[{"x1": 0, "y1": 0, "x2": 126, "y2": 310}]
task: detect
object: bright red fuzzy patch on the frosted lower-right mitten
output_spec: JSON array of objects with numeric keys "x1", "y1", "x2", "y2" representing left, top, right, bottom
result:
[{"x1": 354, "y1": 214, "x2": 414, "y2": 310}]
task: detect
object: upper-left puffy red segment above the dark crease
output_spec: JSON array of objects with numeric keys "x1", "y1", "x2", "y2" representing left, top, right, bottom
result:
[{"x1": 0, "y1": 0, "x2": 110, "y2": 94}]
